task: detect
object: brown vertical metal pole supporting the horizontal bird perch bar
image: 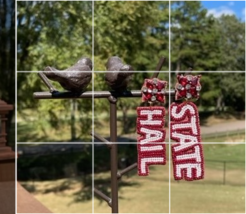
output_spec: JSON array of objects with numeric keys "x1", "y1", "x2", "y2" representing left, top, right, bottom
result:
[{"x1": 108, "y1": 96, "x2": 118, "y2": 213}]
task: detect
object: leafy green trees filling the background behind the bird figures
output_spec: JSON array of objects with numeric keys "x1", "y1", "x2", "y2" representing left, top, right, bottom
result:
[{"x1": 14, "y1": 1, "x2": 245, "y2": 142}]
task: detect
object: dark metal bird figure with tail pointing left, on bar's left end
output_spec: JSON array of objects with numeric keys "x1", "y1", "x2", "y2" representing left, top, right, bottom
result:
[{"x1": 44, "y1": 57, "x2": 92, "y2": 93}]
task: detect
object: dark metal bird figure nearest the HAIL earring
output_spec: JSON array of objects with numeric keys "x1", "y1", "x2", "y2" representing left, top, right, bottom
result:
[{"x1": 105, "y1": 56, "x2": 133, "y2": 91}]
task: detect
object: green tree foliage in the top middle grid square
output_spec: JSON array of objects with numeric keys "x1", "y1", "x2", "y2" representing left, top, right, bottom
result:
[{"x1": 94, "y1": 1, "x2": 169, "y2": 71}]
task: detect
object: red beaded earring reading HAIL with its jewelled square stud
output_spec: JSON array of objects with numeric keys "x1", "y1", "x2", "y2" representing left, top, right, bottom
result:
[{"x1": 137, "y1": 78, "x2": 167, "y2": 176}]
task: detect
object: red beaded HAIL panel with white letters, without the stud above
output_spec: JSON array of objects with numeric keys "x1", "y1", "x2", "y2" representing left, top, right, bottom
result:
[{"x1": 137, "y1": 106, "x2": 166, "y2": 176}]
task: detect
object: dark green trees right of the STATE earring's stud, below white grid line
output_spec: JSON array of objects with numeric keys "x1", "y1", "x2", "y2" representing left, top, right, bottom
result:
[{"x1": 200, "y1": 72, "x2": 245, "y2": 114}]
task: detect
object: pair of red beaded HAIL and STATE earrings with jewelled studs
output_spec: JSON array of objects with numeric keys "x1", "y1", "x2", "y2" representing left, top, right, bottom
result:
[{"x1": 137, "y1": 75, "x2": 204, "y2": 181}]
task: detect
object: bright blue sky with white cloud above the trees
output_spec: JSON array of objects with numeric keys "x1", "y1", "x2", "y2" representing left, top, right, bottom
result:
[{"x1": 201, "y1": 1, "x2": 245, "y2": 21}]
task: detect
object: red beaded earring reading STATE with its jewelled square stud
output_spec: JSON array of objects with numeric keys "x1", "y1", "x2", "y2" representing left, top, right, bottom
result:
[{"x1": 170, "y1": 74, "x2": 204, "y2": 181}]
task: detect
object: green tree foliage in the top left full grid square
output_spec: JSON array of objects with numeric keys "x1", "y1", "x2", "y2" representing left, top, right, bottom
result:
[{"x1": 17, "y1": 1, "x2": 92, "y2": 71}]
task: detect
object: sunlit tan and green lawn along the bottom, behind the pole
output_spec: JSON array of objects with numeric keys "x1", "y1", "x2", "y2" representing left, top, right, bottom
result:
[{"x1": 19, "y1": 145, "x2": 245, "y2": 213}]
